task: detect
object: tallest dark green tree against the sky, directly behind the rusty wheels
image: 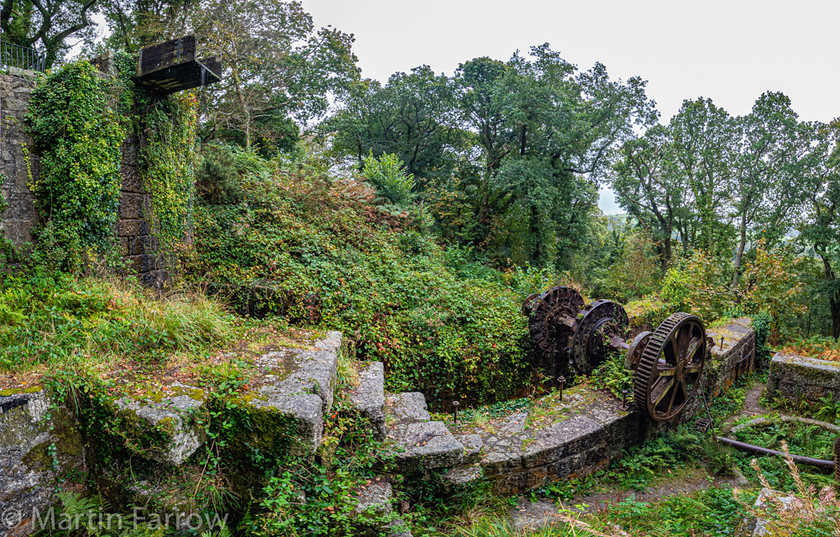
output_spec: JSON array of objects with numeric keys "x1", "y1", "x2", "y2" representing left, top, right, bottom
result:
[{"x1": 488, "y1": 45, "x2": 656, "y2": 268}]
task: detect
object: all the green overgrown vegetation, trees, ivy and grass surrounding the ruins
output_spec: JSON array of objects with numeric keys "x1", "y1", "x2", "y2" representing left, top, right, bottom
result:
[{"x1": 0, "y1": 0, "x2": 840, "y2": 537}]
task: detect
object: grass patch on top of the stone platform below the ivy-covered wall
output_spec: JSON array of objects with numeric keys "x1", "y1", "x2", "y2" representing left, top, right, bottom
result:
[{"x1": 0, "y1": 272, "x2": 324, "y2": 395}]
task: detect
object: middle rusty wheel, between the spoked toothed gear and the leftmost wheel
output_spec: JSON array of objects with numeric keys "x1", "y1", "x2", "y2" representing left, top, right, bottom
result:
[{"x1": 572, "y1": 300, "x2": 629, "y2": 375}]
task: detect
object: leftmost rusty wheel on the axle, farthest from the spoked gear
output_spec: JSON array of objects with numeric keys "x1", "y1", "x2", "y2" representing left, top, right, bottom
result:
[{"x1": 522, "y1": 285, "x2": 583, "y2": 354}]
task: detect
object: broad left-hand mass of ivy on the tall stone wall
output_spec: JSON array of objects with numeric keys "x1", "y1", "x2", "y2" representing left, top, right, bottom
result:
[{"x1": 26, "y1": 61, "x2": 126, "y2": 259}]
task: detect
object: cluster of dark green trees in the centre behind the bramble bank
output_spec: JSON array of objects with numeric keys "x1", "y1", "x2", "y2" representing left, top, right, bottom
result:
[{"x1": 325, "y1": 44, "x2": 656, "y2": 270}]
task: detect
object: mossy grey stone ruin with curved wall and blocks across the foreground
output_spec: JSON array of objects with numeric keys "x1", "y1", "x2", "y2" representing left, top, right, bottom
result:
[{"x1": 0, "y1": 319, "x2": 755, "y2": 537}]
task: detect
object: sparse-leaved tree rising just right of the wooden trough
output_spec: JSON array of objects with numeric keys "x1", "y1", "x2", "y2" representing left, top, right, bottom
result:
[{"x1": 192, "y1": 0, "x2": 359, "y2": 150}]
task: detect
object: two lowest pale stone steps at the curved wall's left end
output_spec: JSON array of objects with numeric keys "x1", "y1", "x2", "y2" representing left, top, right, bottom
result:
[{"x1": 386, "y1": 392, "x2": 465, "y2": 473}]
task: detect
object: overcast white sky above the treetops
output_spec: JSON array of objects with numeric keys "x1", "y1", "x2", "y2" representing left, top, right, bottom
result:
[{"x1": 302, "y1": 0, "x2": 840, "y2": 214}]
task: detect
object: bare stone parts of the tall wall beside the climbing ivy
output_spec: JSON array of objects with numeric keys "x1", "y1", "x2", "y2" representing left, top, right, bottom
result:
[{"x1": 0, "y1": 73, "x2": 166, "y2": 285}]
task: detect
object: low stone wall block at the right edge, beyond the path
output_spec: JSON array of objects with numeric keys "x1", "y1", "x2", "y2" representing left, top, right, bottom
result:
[{"x1": 767, "y1": 352, "x2": 840, "y2": 404}]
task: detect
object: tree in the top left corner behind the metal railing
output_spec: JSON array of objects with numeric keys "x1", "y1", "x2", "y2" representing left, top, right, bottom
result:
[{"x1": 0, "y1": 0, "x2": 101, "y2": 69}]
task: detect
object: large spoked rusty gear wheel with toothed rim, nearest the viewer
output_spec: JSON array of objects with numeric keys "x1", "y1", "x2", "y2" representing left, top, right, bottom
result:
[{"x1": 633, "y1": 313, "x2": 708, "y2": 421}]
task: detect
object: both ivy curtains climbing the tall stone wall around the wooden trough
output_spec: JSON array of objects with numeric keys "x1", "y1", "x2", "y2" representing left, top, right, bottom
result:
[{"x1": 26, "y1": 53, "x2": 197, "y2": 269}]
